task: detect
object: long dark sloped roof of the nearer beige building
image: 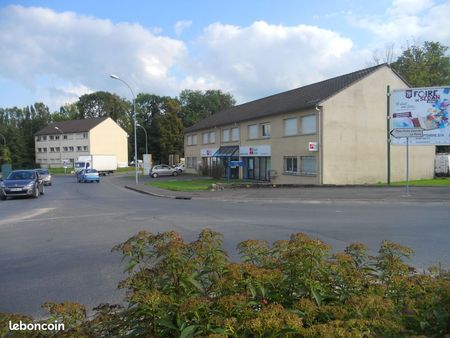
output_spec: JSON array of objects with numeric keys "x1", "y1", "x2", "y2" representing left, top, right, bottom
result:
[{"x1": 185, "y1": 64, "x2": 387, "y2": 133}]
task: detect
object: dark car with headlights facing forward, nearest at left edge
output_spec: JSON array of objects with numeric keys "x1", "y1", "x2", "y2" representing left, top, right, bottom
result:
[{"x1": 0, "y1": 170, "x2": 45, "y2": 200}]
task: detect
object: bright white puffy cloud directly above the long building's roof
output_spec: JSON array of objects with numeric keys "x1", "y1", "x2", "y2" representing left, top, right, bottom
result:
[{"x1": 186, "y1": 21, "x2": 365, "y2": 101}]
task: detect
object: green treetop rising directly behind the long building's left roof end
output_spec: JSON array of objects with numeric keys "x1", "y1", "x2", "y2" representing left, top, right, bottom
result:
[{"x1": 179, "y1": 89, "x2": 236, "y2": 127}]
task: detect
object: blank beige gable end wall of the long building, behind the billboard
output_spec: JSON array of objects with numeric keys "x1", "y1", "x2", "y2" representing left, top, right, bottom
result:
[{"x1": 322, "y1": 67, "x2": 435, "y2": 184}]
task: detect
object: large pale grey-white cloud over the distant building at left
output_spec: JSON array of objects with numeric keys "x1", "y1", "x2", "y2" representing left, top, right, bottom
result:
[{"x1": 0, "y1": 6, "x2": 187, "y2": 106}]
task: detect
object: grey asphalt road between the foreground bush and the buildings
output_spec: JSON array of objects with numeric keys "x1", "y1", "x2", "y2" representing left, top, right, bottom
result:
[{"x1": 0, "y1": 176, "x2": 450, "y2": 316}]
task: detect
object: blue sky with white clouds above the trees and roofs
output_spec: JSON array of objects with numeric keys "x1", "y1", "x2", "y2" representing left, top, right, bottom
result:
[{"x1": 0, "y1": 0, "x2": 450, "y2": 111}]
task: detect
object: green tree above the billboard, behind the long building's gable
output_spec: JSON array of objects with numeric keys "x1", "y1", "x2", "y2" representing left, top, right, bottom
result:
[{"x1": 392, "y1": 41, "x2": 450, "y2": 87}]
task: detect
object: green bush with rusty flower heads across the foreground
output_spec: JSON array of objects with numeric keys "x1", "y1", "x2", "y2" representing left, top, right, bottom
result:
[{"x1": 0, "y1": 230, "x2": 450, "y2": 337}]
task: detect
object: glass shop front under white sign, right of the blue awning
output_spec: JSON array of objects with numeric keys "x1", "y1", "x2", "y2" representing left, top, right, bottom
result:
[{"x1": 239, "y1": 145, "x2": 271, "y2": 181}]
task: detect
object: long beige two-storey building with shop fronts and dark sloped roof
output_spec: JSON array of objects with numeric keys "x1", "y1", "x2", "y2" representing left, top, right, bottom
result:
[{"x1": 184, "y1": 65, "x2": 435, "y2": 185}]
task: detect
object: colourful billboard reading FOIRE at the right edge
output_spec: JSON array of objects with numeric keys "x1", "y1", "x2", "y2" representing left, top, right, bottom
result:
[{"x1": 391, "y1": 86, "x2": 450, "y2": 145}]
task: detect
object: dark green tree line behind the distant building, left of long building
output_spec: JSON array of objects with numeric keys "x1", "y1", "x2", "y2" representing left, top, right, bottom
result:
[{"x1": 0, "y1": 90, "x2": 236, "y2": 168}]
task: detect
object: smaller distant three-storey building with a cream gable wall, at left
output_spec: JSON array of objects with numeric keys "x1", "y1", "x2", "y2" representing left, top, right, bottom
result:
[{"x1": 34, "y1": 117, "x2": 128, "y2": 168}]
